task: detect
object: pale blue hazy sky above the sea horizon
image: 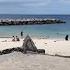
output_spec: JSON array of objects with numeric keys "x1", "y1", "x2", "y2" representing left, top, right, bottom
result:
[{"x1": 0, "y1": 0, "x2": 70, "y2": 14}]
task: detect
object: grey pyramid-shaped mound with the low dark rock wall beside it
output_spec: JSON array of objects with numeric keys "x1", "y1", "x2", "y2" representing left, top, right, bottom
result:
[{"x1": 0, "y1": 35, "x2": 45, "y2": 55}]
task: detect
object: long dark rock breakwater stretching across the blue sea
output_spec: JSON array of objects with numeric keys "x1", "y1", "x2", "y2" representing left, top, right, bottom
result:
[{"x1": 0, "y1": 18, "x2": 65, "y2": 25}]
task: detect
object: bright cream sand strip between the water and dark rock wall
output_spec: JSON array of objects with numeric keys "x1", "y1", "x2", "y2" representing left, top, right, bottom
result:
[{"x1": 0, "y1": 38, "x2": 70, "y2": 56}]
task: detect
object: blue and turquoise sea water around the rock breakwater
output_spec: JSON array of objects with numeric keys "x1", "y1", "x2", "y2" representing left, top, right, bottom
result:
[{"x1": 0, "y1": 14, "x2": 70, "y2": 39}]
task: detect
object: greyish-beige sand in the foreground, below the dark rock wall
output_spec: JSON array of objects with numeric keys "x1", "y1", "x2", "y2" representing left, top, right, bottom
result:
[{"x1": 0, "y1": 52, "x2": 70, "y2": 70}]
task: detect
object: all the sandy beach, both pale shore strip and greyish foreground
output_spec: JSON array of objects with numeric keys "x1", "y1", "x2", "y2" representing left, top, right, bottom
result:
[{"x1": 0, "y1": 38, "x2": 70, "y2": 70}]
